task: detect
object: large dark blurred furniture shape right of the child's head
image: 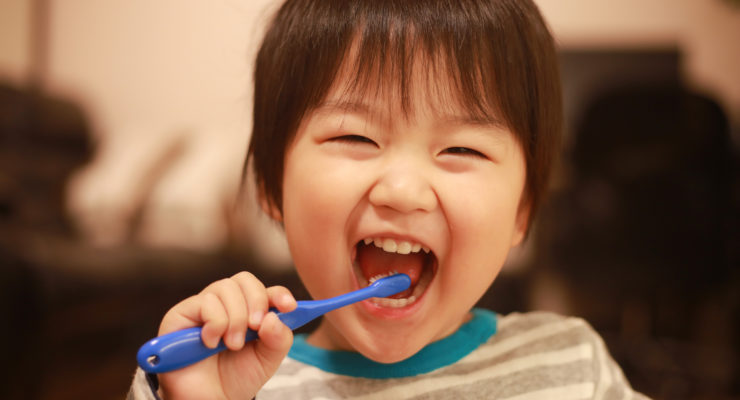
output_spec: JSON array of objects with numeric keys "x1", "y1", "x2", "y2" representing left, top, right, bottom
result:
[{"x1": 534, "y1": 50, "x2": 740, "y2": 399}]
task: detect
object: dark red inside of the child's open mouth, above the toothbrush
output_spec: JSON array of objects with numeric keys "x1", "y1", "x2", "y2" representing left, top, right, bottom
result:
[{"x1": 357, "y1": 245, "x2": 424, "y2": 287}]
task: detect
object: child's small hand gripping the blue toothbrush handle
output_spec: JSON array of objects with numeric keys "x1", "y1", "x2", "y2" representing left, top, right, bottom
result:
[{"x1": 159, "y1": 272, "x2": 296, "y2": 399}]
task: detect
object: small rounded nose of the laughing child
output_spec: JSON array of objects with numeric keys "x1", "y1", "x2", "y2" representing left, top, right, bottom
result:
[{"x1": 369, "y1": 157, "x2": 437, "y2": 213}]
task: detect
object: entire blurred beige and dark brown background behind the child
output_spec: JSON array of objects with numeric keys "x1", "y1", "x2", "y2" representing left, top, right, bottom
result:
[{"x1": 0, "y1": 0, "x2": 740, "y2": 399}]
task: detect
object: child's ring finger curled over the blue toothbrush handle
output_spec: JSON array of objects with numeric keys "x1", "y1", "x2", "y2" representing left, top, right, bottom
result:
[{"x1": 204, "y1": 279, "x2": 248, "y2": 350}]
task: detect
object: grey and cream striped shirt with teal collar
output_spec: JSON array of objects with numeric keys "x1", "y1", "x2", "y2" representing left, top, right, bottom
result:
[{"x1": 129, "y1": 309, "x2": 646, "y2": 400}]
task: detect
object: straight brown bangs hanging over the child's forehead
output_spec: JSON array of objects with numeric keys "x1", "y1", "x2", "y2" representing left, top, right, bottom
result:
[{"x1": 334, "y1": 5, "x2": 508, "y2": 125}]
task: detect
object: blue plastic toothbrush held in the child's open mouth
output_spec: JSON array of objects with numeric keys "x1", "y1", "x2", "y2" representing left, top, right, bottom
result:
[{"x1": 136, "y1": 274, "x2": 411, "y2": 373}]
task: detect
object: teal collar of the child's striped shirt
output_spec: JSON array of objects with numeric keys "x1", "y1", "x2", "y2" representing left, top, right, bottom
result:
[{"x1": 288, "y1": 308, "x2": 496, "y2": 379}]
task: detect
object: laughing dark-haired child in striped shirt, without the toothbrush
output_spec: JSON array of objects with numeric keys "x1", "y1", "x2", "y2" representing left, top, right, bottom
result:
[{"x1": 130, "y1": 0, "x2": 642, "y2": 399}]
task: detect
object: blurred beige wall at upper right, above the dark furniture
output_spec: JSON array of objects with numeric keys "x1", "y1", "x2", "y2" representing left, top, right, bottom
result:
[{"x1": 537, "y1": 0, "x2": 740, "y2": 130}]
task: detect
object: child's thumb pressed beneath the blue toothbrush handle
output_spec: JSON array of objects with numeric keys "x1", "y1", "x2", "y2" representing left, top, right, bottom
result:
[{"x1": 254, "y1": 312, "x2": 293, "y2": 377}]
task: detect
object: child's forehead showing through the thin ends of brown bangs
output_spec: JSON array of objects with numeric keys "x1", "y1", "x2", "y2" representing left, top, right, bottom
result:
[{"x1": 315, "y1": 42, "x2": 503, "y2": 125}]
